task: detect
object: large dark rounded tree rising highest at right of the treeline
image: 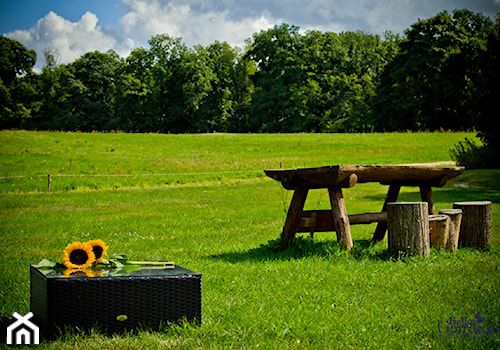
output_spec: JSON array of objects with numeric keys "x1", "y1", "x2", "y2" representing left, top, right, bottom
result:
[{"x1": 377, "y1": 10, "x2": 492, "y2": 130}]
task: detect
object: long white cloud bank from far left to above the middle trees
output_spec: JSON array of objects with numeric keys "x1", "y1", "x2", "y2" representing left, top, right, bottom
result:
[{"x1": 6, "y1": 0, "x2": 279, "y2": 71}]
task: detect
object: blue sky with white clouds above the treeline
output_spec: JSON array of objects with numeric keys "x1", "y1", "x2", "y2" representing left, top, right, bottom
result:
[{"x1": 0, "y1": 0, "x2": 500, "y2": 68}]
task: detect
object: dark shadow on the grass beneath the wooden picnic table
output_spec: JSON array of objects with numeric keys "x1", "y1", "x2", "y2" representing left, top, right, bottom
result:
[{"x1": 211, "y1": 236, "x2": 394, "y2": 263}]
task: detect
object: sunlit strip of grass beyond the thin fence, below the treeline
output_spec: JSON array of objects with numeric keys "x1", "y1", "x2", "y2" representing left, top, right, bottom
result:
[{"x1": 0, "y1": 131, "x2": 474, "y2": 192}]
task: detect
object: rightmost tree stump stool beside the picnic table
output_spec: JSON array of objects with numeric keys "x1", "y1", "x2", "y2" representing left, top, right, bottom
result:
[{"x1": 453, "y1": 201, "x2": 491, "y2": 249}]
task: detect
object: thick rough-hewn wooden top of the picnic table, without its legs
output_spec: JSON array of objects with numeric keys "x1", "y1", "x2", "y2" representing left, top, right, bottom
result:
[{"x1": 264, "y1": 164, "x2": 465, "y2": 190}]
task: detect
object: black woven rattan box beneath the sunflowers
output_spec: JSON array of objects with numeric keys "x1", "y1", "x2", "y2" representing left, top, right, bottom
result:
[{"x1": 30, "y1": 266, "x2": 202, "y2": 337}]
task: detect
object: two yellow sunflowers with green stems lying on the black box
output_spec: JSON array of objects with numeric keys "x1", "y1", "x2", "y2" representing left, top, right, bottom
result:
[{"x1": 34, "y1": 239, "x2": 175, "y2": 277}]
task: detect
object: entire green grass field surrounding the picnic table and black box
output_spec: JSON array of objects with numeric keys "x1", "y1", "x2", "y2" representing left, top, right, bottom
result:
[{"x1": 0, "y1": 131, "x2": 500, "y2": 349}]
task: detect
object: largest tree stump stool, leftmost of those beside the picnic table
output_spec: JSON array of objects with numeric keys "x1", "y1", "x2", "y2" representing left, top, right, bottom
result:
[{"x1": 387, "y1": 202, "x2": 430, "y2": 257}]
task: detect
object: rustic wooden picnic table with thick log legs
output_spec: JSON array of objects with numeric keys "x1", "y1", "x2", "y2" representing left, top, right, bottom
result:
[{"x1": 264, "y1": 164, "x2": 465, "y2": 250}]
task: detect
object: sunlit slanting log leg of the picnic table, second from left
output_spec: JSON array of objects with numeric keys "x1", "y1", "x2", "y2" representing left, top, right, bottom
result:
[{"x1": 328, "y1": 187, "x2": 353, "y2": 250}]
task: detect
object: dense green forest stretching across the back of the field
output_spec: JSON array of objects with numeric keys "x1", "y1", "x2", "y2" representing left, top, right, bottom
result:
[{"x1": 0, "y1": 10, "x2": 500, "y2": 138}]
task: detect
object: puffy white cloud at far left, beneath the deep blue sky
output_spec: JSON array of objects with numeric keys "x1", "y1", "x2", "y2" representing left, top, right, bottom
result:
[{"x1": 6, "y1": 11, "x2": 134, "y2": 70}]
